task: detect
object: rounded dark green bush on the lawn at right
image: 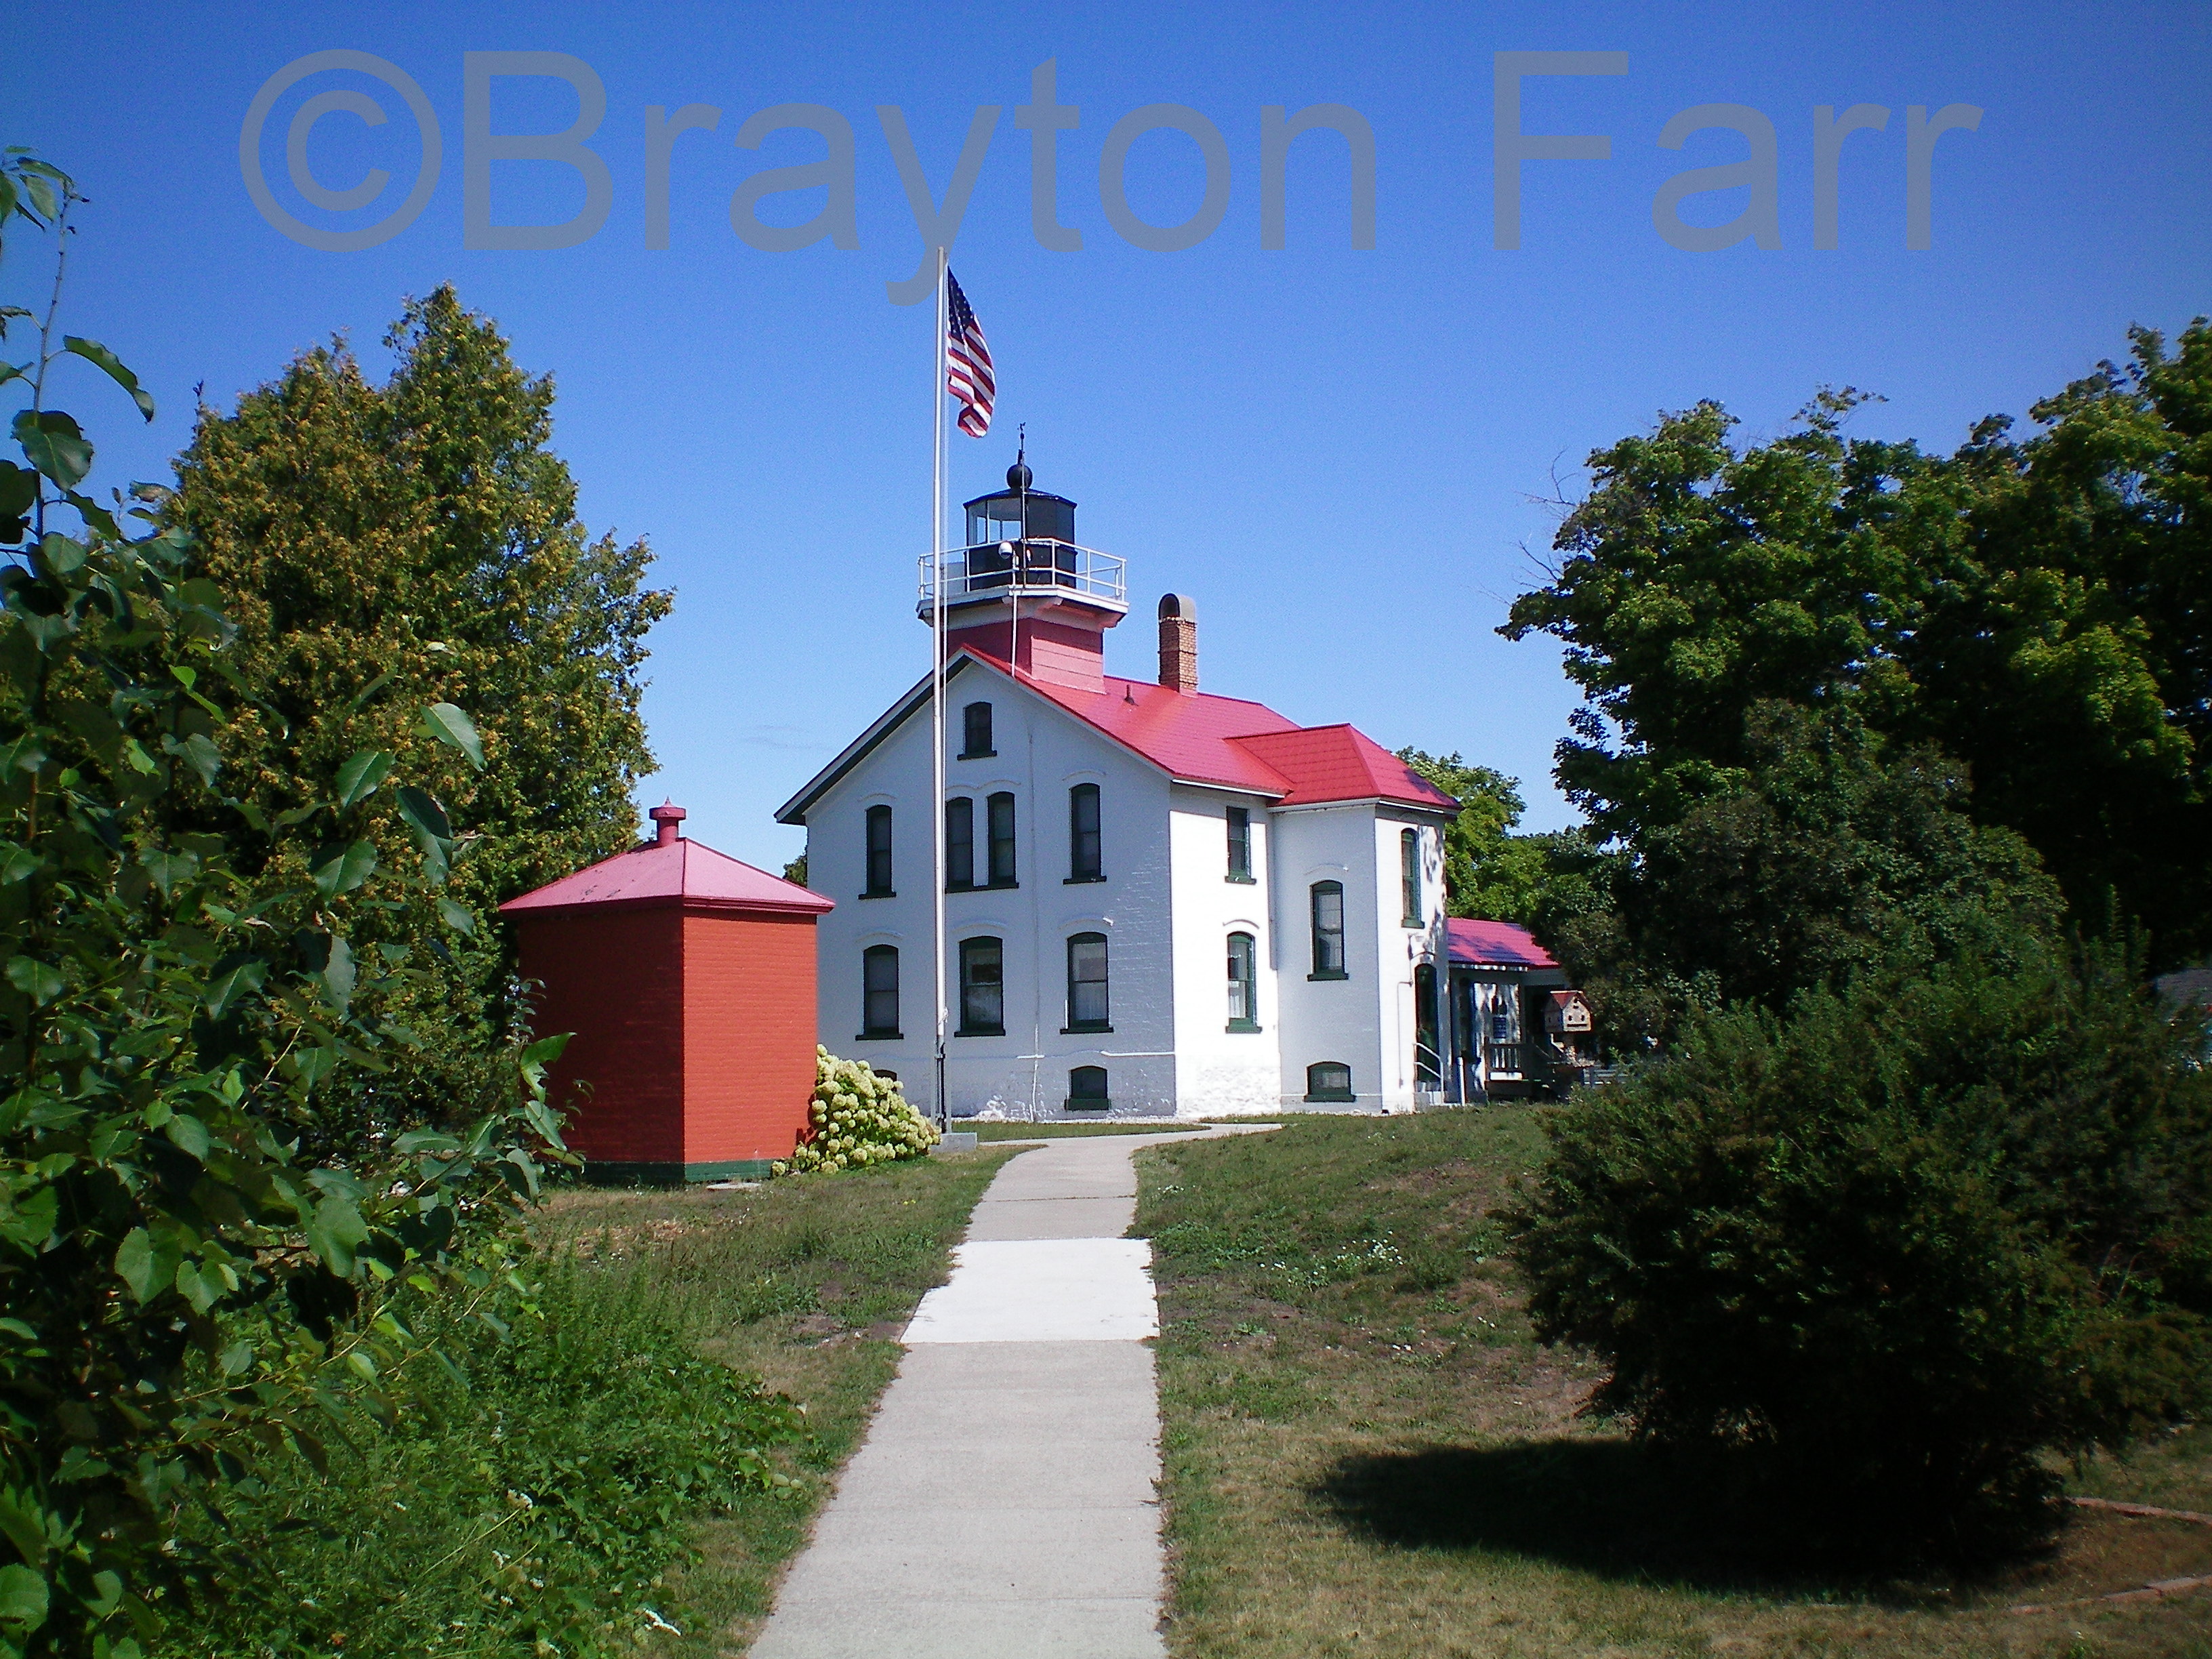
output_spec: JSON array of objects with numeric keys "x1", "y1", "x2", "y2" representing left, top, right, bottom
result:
[{"x1": 1513, "y1": 951, "x2": 2212, "y2": 1544}]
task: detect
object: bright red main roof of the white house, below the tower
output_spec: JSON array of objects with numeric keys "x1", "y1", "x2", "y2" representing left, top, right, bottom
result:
[{"x1": 1000, "y1": 646, "x2": 1458, "y2": 812}]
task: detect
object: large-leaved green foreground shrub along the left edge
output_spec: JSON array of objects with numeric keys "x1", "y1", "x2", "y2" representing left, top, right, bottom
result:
[{"x1": 0, "y1": 152, "x2": 567, "y2": 1659}]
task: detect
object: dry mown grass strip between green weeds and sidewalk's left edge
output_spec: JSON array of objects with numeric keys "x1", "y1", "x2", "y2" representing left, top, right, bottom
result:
[{"x1": 542, "y1": 1148, "x2": 1013, "y2": 1659}]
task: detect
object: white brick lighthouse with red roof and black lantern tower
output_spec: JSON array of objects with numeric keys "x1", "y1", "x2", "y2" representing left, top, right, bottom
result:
[{"x1": 777, "y1": 462, "x2": 1456, "y2": 1117}]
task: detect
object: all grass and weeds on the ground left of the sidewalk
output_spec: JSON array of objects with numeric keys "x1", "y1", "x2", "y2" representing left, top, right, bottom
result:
[{"x1": 177, "y1": 1148, "x2": 1011, "y2": 1659}]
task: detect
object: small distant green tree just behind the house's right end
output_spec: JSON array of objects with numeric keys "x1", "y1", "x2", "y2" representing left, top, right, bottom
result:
[{"x1": 1398, "y1": 747, "x2": 1595, "y2": 931}]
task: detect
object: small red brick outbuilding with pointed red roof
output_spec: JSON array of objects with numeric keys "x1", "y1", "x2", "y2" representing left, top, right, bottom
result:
[{"x1": 500, "y1": 805, "x2": 832, "y2": 1183}]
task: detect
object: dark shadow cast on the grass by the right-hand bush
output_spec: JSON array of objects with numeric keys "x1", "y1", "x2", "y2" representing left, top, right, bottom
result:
[{"x1": 1312, "y1": 1435, "x2": 2046, "y2": 1603}]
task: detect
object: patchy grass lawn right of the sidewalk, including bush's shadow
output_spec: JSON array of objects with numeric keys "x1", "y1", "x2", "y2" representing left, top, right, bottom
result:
[{"x1": 1134, "y1": 1106, "x2": 2212, "y2": 1659}]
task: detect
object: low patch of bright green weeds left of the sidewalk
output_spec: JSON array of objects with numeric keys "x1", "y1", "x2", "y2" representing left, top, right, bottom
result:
[{"x1": 184, "y1": 1250, "x2": 803, "y2": 1659}]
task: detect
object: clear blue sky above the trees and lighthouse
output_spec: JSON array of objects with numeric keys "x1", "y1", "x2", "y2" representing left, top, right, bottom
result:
[{"x1": 0, "y1": 0, "x2": 2212, "y2": 867}]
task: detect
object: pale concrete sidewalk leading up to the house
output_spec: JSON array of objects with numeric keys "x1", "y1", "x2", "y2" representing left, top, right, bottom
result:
[{"x1": 752, "y1": 1124, "x2": 1274, "y2": 1659}]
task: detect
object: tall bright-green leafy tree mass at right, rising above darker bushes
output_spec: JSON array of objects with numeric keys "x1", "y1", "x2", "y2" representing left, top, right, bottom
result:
[{"x1": 1502, "y1": 319, "x2": 2212, "y2": 962}]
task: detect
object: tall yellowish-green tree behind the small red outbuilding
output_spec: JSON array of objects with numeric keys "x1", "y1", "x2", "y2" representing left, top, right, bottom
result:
[{"x1": 168, "y1": 287, "x2": 668, "y2": 1132}]
